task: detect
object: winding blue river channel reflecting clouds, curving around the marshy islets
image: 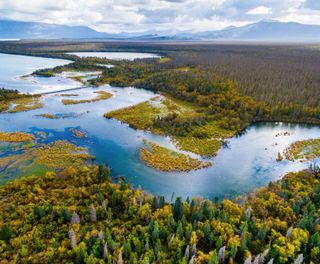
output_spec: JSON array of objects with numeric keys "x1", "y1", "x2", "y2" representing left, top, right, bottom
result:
[{"x1": 0, "y1": 54, "x2": 320, "y2": 198}]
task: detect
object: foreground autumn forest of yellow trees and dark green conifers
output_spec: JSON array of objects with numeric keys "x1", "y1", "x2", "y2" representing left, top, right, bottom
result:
[{"x1": 0, "y1": 166, "x2": 320, "y2": 264}]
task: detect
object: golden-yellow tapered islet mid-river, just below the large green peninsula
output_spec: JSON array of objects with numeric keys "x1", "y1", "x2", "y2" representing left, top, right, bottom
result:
[{"x1": 140, "y1": 140, "x2": 212, "y2": 171}]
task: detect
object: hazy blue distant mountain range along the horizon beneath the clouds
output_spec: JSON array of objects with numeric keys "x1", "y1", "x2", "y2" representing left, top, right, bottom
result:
[{"x1": 0, "y1": 20, "x2": 320, "y2": 41}]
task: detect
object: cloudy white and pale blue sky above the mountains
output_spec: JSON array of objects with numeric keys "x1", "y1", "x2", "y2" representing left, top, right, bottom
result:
[{"x1": 0, "y1": 0, "x2": 320, "y2": 32}]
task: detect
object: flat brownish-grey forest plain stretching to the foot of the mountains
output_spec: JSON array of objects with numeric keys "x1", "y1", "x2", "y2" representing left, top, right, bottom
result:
[{"x1": 0, "y1": 41, "x2": 320, "y2": 107}]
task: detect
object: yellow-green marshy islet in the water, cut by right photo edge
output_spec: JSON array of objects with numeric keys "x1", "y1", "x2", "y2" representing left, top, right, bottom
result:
[{"x1": 283, "y1": 138, "x2": 320, "y2": 161}]
